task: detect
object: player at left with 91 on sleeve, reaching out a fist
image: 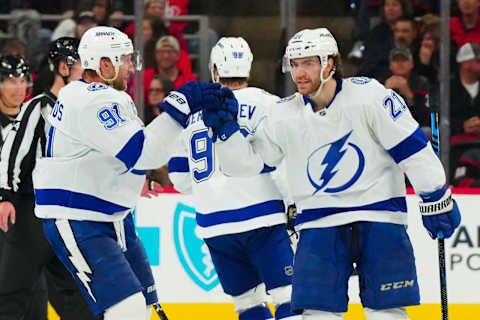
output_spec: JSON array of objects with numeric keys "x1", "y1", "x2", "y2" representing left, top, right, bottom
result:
[{"x1": 33, "y1": 27, "x2": 220, "y2": 320}]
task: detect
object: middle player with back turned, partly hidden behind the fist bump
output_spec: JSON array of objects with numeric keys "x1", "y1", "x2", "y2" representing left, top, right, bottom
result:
[{"x1": 169, "y1": 37, "x2": 301, "y2": 320}]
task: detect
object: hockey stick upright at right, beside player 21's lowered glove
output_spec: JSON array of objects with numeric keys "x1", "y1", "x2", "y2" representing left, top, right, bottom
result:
[{"x1": 430, "y1": 110, "x2": 448, "y2": 320}]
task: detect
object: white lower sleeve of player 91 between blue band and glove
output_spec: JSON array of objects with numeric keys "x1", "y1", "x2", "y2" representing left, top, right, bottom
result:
[{"x1": 135, "y1": 113, "x2": 183, "y2": 170}]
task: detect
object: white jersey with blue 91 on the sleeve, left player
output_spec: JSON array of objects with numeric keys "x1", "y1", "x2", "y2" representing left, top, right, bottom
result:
[{"x1": 33, "y1": 80, "x2": 182, "y2": 221}]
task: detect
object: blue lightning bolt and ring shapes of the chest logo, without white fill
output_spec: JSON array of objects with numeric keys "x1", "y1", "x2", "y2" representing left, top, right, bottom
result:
[{"x1": 307, "y1": 130, "x2": 365, "y2": 194}]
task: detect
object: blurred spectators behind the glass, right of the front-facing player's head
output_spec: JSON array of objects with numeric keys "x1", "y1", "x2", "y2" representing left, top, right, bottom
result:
[{"x1": 347, "y1": 0, "x2": 480, "y2": 187}]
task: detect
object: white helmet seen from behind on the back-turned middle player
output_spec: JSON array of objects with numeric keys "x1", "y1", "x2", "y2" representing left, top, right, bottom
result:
[{"x1": 209, "y1": 37, "x2": 253, "y2": 82}]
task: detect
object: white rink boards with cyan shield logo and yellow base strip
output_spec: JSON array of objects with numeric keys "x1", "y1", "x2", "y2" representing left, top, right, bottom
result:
[{"x1": 47, "y1": 190, "x2": 480, "y2": 320}]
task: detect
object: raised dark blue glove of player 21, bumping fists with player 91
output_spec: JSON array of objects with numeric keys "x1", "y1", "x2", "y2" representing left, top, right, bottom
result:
[{"x1": 202, "y1": 87, "x2": 240, "y2": 142}]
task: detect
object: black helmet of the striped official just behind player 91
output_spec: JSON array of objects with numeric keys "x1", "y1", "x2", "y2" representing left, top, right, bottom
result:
[{"x1": 48, "y1": 37, "x2": 80, "y2": 71}]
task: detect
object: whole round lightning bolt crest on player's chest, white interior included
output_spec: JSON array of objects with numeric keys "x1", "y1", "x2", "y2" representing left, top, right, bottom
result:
[{"x1": 307, "y1": 131, "x2": 365, "y2": 194}]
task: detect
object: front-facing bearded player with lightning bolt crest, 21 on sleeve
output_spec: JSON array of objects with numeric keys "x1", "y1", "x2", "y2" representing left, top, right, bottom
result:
[{"x1": 203, "y1": 28, "x2": 460, "y2": 320}]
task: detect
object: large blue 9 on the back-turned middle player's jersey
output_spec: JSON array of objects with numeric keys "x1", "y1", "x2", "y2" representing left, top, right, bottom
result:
[{"x1": 190, "y1": 129, "x2": 215, "y2": 182}]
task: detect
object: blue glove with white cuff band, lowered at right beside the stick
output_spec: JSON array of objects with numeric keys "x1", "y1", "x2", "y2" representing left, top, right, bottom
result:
[{"x1": 419, "y1": 186, "x2": 461, "y2": 239}]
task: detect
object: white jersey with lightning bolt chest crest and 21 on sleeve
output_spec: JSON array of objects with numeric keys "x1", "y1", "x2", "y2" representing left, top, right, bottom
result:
[{"x1": 215, "y1": 77, "x2": 445, "y2": 230}]
